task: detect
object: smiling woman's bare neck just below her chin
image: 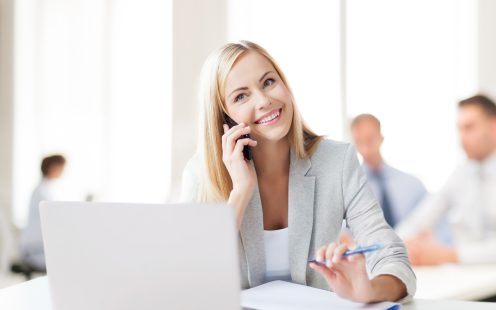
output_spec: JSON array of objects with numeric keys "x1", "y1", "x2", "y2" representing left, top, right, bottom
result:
[{"x1": 253, "y1": 139, "x2": 290, "y2": 178}]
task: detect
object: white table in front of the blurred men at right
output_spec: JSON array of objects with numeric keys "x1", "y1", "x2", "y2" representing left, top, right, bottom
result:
[{"x1": 414, "y1": 265, "x2": 496, "y2": 300}]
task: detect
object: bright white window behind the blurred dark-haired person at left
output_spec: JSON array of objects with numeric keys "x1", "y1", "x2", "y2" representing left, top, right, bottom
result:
[{"x1": 14, "y1": 0, "x2": 172, "y2": 226}]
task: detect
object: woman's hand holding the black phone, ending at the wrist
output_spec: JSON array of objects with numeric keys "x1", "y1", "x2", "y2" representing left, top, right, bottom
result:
[{"x1": 222, "y1": 123, "x2": 257, "y2": 191}]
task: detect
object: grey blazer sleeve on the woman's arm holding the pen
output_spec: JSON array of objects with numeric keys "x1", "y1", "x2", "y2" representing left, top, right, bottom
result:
[{"x1": 342, "y1": 145, "x2": 416, "y2": 302}]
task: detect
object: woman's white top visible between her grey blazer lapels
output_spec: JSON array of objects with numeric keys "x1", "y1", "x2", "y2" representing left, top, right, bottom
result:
[{"x1": 264, "y1": 227, "x2": 291, "y2": 282}]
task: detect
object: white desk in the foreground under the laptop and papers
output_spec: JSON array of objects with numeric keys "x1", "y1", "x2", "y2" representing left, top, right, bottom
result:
[{"x1": 0, "y1": 277, "x2": 496, "y2": 310}]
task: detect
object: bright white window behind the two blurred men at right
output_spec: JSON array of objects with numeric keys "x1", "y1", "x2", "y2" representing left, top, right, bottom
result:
[{"x1": 346, "y1": 0, "x2": 477, "y2": 189}]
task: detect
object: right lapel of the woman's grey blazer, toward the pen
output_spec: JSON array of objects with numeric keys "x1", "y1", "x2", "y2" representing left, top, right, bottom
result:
[{"x1": 288, "y1": 150, "x2": 315, "y2": 284}]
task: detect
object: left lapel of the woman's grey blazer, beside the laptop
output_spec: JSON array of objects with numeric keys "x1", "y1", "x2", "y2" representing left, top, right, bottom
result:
[{"x1": 240, "y1": 184, "x2": 265, "y2": 287}]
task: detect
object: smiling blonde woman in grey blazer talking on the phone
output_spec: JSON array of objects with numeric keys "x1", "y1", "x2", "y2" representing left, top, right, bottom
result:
[{"x1": 182, "y1": 41, "x2": 416, "y2": 302}]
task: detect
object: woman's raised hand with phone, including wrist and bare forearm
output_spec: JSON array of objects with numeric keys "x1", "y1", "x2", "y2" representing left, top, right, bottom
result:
[{"x1": 222, "y1": 123, "x2": 257, "y2": 229}]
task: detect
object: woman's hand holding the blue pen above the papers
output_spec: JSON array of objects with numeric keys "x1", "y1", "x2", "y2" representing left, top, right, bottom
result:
[{"x1": 310, "y1": 243, "x2": 374, "y2": 303}]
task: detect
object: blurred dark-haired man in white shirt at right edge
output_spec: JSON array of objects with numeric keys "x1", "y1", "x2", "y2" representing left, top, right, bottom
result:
[{"x1": 398, "y1": 95, "x2": 496, "y2": 265}]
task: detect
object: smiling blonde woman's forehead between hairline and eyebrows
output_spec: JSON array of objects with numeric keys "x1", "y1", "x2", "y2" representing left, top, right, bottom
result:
[{"x1": 225, "y1": 51, "x2": 275, "y2": 95}]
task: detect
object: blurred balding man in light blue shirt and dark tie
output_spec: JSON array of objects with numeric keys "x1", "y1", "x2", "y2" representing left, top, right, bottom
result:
[{"x1": 351, "y1": 114, "x2": 427, "y2": 228}]
